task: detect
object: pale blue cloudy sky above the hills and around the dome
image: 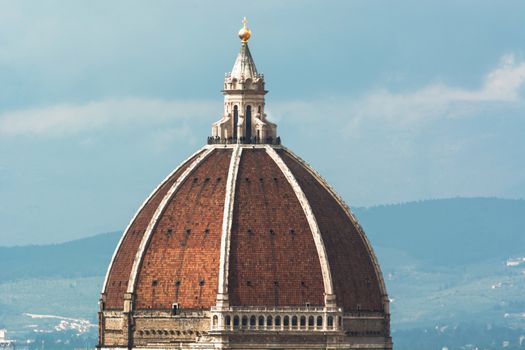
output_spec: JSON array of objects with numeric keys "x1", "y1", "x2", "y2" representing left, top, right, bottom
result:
[{"x1": 0, "y1": 0, "x2": 525, "y2": 246}]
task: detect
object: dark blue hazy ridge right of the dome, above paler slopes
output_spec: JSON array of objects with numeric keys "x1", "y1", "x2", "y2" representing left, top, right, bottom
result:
[{"x1": 353, "y1": 198, "x2": 525, "y2": 266}]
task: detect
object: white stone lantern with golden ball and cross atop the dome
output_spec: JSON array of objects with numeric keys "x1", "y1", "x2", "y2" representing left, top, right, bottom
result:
[{"x1": 208, "y1": 17, "x2": 280, "y2": 144}]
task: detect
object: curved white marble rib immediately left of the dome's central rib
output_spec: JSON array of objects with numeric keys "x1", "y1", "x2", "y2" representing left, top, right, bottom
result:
[{"x1": 127, "y1": 147, "x2": 215, "y2": 293}]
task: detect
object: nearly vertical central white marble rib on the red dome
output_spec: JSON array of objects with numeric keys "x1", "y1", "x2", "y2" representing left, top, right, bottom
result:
[{"x1": 217, "y1": 145, "x2": 243, "y2": 308}]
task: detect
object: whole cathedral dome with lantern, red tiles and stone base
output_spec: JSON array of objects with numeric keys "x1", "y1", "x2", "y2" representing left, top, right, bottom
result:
[{"x1": 98, "y1": 19, "x2": 392, "y2": 349}]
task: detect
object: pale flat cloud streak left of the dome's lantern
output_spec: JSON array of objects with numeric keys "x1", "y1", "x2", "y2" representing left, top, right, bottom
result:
[{"x1": 0, "y1": 98, "x2": 216, "y2": 136}]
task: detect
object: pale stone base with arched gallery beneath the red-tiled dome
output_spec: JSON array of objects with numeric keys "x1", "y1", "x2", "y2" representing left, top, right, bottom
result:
[{"x1": 101, "y1": 307, "x2": 392, "y2": 349}]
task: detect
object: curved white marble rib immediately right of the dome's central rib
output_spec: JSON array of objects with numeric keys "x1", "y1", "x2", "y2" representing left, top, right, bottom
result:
[{"x1": 266, "y1": 146, "x2": 334, "y2": 296}]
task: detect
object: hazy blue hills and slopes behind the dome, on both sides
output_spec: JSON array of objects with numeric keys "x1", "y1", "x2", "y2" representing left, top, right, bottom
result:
[{"x1": 0, "y1": 198, "x2": 525, "y2": 349}]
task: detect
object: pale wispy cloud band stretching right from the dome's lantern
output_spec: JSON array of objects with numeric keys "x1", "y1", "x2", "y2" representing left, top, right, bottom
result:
[{"x1": 272, "y1": 54, "x2": 525, "y2": 134}]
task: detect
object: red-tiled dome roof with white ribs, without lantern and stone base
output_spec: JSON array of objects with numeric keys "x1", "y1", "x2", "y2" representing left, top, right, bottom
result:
[{"x1": 102, "y1": 145, "x2": 388, "y2": 311}]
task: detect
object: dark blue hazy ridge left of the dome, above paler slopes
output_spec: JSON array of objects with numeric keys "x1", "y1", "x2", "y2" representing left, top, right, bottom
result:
[{"x1": 0, "y1": 232, "x2": 121, "y2": 283}]
